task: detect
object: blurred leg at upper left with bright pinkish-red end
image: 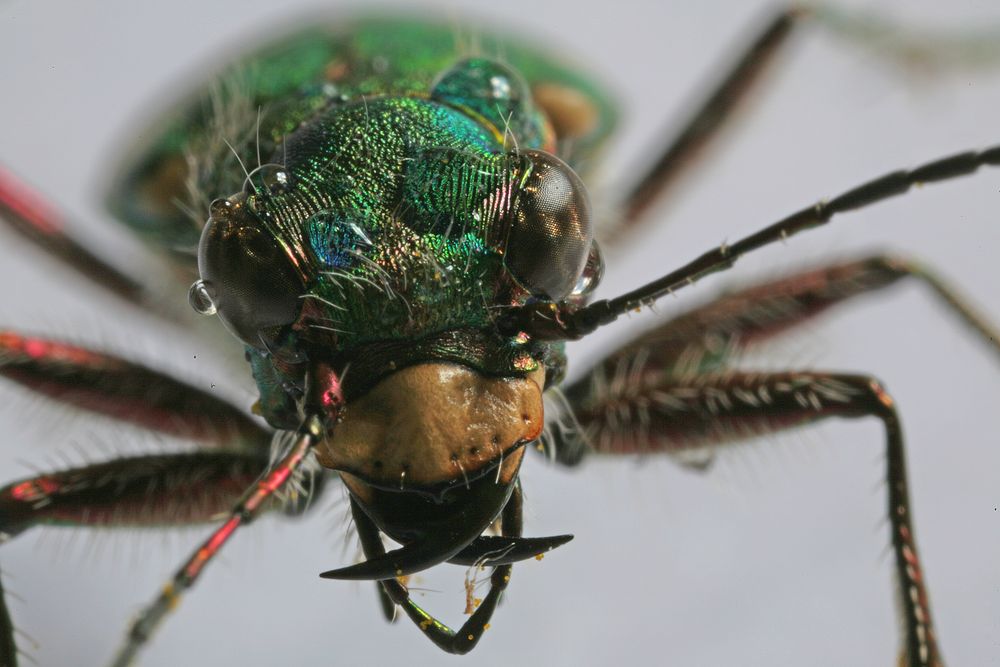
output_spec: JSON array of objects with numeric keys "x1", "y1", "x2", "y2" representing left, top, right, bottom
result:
[{"x1": 0, "y1": 167, "x2": 144, "y2": 305}]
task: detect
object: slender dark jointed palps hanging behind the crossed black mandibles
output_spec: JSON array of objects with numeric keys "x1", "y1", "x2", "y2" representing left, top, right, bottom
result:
[{"x1": 351, "y1": 482, "x2": 524, "y2": 655}]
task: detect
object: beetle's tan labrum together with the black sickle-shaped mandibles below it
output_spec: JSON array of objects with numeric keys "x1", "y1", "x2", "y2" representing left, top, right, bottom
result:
[{"x1": 317, "y1": 362, "x2": 551, "y2": 579}]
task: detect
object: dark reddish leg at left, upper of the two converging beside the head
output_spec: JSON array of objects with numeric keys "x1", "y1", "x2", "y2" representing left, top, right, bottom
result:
[{"x1": 0, "y1": 330, "x2": 271, "y2": 452}]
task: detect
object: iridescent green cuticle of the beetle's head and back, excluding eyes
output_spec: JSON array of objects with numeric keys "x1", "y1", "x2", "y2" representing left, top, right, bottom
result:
[{"x1": 105, "y1": 19, "x2": 613, "y2": 428}]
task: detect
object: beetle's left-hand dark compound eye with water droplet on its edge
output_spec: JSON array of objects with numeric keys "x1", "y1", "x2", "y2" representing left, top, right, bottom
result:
[{"x1": 189, "y1": 199, "x2": 304, "y2": 349}]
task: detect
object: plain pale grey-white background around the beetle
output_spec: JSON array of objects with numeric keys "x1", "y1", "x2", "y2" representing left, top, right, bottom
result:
[{"x1": 0, "y1": 0, "x2": 1000, "y2": 666}]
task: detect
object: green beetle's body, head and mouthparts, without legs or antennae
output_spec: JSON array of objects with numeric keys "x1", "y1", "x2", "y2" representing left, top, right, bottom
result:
[{"x1": 113, "y1": 20, "x2": 611, "y2": 653}]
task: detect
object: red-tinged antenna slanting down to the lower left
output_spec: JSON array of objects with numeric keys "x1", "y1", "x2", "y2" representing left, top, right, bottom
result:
[{"x1": 112, "y1": 417, "x2": 325, "y2": 667}]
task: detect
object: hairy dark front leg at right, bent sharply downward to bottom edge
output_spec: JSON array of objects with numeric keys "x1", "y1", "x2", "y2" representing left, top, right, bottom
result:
[{"x1": 575, "y1": 371, "x2": 942, "y2": 667}]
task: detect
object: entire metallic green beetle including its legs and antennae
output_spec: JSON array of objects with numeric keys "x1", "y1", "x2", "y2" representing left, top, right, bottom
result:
[{"x1": 0, "y1": 6, "x2": 1000, "y2": 665}]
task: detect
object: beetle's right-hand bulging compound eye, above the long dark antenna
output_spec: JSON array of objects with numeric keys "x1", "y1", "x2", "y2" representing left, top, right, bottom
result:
[{"x1": 503, "y1": 150, "x2": 594, "y2": 301}]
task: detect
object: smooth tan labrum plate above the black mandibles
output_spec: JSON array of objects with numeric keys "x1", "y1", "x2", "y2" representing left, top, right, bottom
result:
[{"x1": 317, "y1": 362, "x2": 545, "y2": 491}]
